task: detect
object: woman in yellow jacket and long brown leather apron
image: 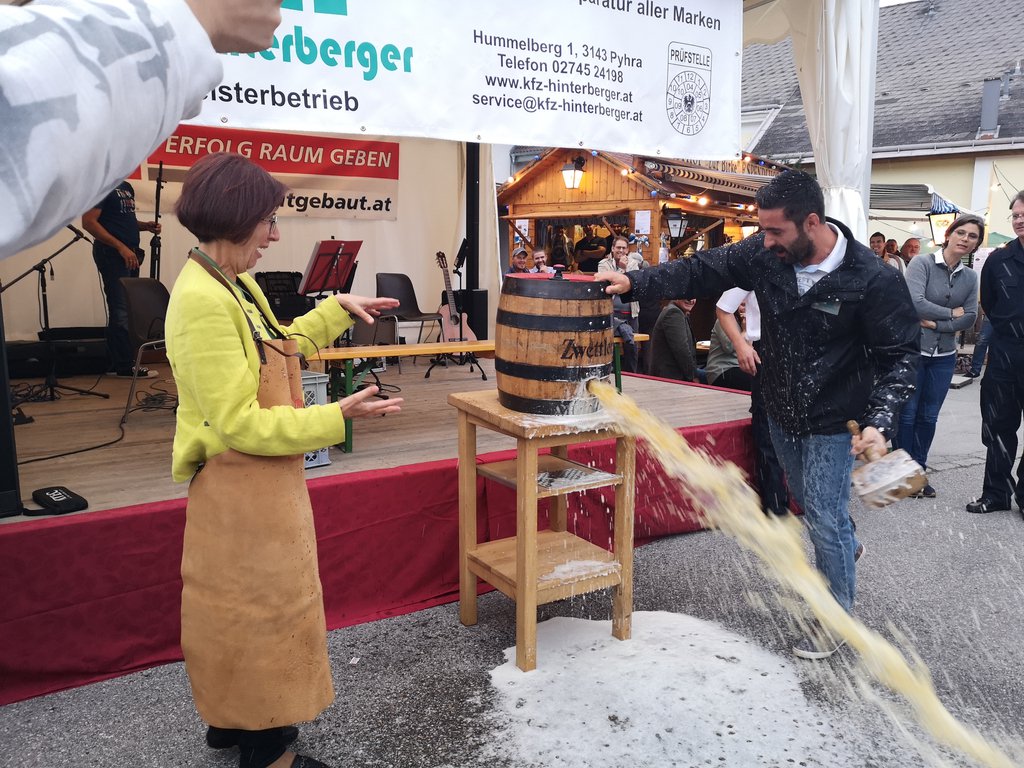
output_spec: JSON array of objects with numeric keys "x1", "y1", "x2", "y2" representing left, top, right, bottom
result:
[{"x1": 166, "y1": 154, "x2": 401, "y2": 768}]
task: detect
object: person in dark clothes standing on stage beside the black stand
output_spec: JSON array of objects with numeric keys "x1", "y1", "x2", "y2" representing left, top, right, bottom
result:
[{"x1": 82, "y1": 181, "x2": 160, "y2": 378}]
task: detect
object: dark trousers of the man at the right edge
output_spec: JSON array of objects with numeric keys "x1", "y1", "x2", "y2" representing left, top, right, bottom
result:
[{"x1": 981, "y1": 337, "x2": 1024, "y2": 507}]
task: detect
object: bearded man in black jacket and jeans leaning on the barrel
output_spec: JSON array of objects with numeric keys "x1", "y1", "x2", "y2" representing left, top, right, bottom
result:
[{"x1": 597, "y1": 171, "x2": 921, "y2": 658}]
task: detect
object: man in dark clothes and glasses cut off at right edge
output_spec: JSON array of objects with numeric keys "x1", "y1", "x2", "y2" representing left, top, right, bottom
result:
[{"x1": 967, "y1": 190, "x2": 1024, "y2": 513}]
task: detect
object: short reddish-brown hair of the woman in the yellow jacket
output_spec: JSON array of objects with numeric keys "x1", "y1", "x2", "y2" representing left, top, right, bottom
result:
[{"x1": 174, "y1": 152, "x2": 288, "y2": 244}]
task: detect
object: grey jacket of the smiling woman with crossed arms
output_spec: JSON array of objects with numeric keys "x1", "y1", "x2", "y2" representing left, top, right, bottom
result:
[{"x1": 906, "y1": 252, "x2": 978, "y2": 354}]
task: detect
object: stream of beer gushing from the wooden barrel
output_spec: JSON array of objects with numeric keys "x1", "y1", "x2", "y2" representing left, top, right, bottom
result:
[{"x1": 589, "y1": 381, "x2": 1016, "y2": 768}]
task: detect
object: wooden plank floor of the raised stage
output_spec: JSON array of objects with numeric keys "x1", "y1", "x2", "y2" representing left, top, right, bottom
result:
[{"x1": 0, "y1": 358, "x2": 750, "y2": 524}]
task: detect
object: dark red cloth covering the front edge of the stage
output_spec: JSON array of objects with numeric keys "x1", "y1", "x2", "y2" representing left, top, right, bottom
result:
[{"x1": 0, "y1": 419, "x2": 753, "y2": 705}]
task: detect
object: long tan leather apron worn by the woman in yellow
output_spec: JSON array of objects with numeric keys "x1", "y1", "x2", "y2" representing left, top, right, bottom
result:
[{"x1": 181, "y1": 268, "x2": 334, "y2": 730}]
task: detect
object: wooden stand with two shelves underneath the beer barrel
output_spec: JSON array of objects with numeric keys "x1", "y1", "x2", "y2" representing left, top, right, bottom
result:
[{"x1": 447, "y1": 390, "x2": 636, "y2": 672}]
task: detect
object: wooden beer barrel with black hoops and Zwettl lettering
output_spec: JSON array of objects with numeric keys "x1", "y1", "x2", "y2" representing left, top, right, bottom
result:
[{"x1": 495, "y1": 272, "x2": 614, "y2": 416}]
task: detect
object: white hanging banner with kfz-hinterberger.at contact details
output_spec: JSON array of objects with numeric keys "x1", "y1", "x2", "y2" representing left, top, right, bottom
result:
[{"x1": 195, "y1": 0, "x2": 742, "y2": 160}]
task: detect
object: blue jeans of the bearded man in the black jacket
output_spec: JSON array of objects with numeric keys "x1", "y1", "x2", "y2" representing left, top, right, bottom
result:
[{"x1": 768, "y1": 419, "x2": 857, "y2": 612}]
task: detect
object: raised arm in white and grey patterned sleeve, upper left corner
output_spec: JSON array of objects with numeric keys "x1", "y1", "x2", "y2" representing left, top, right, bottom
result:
[{"x1": 0, "y1": 0, "x2": 282, "y2": 258}]
